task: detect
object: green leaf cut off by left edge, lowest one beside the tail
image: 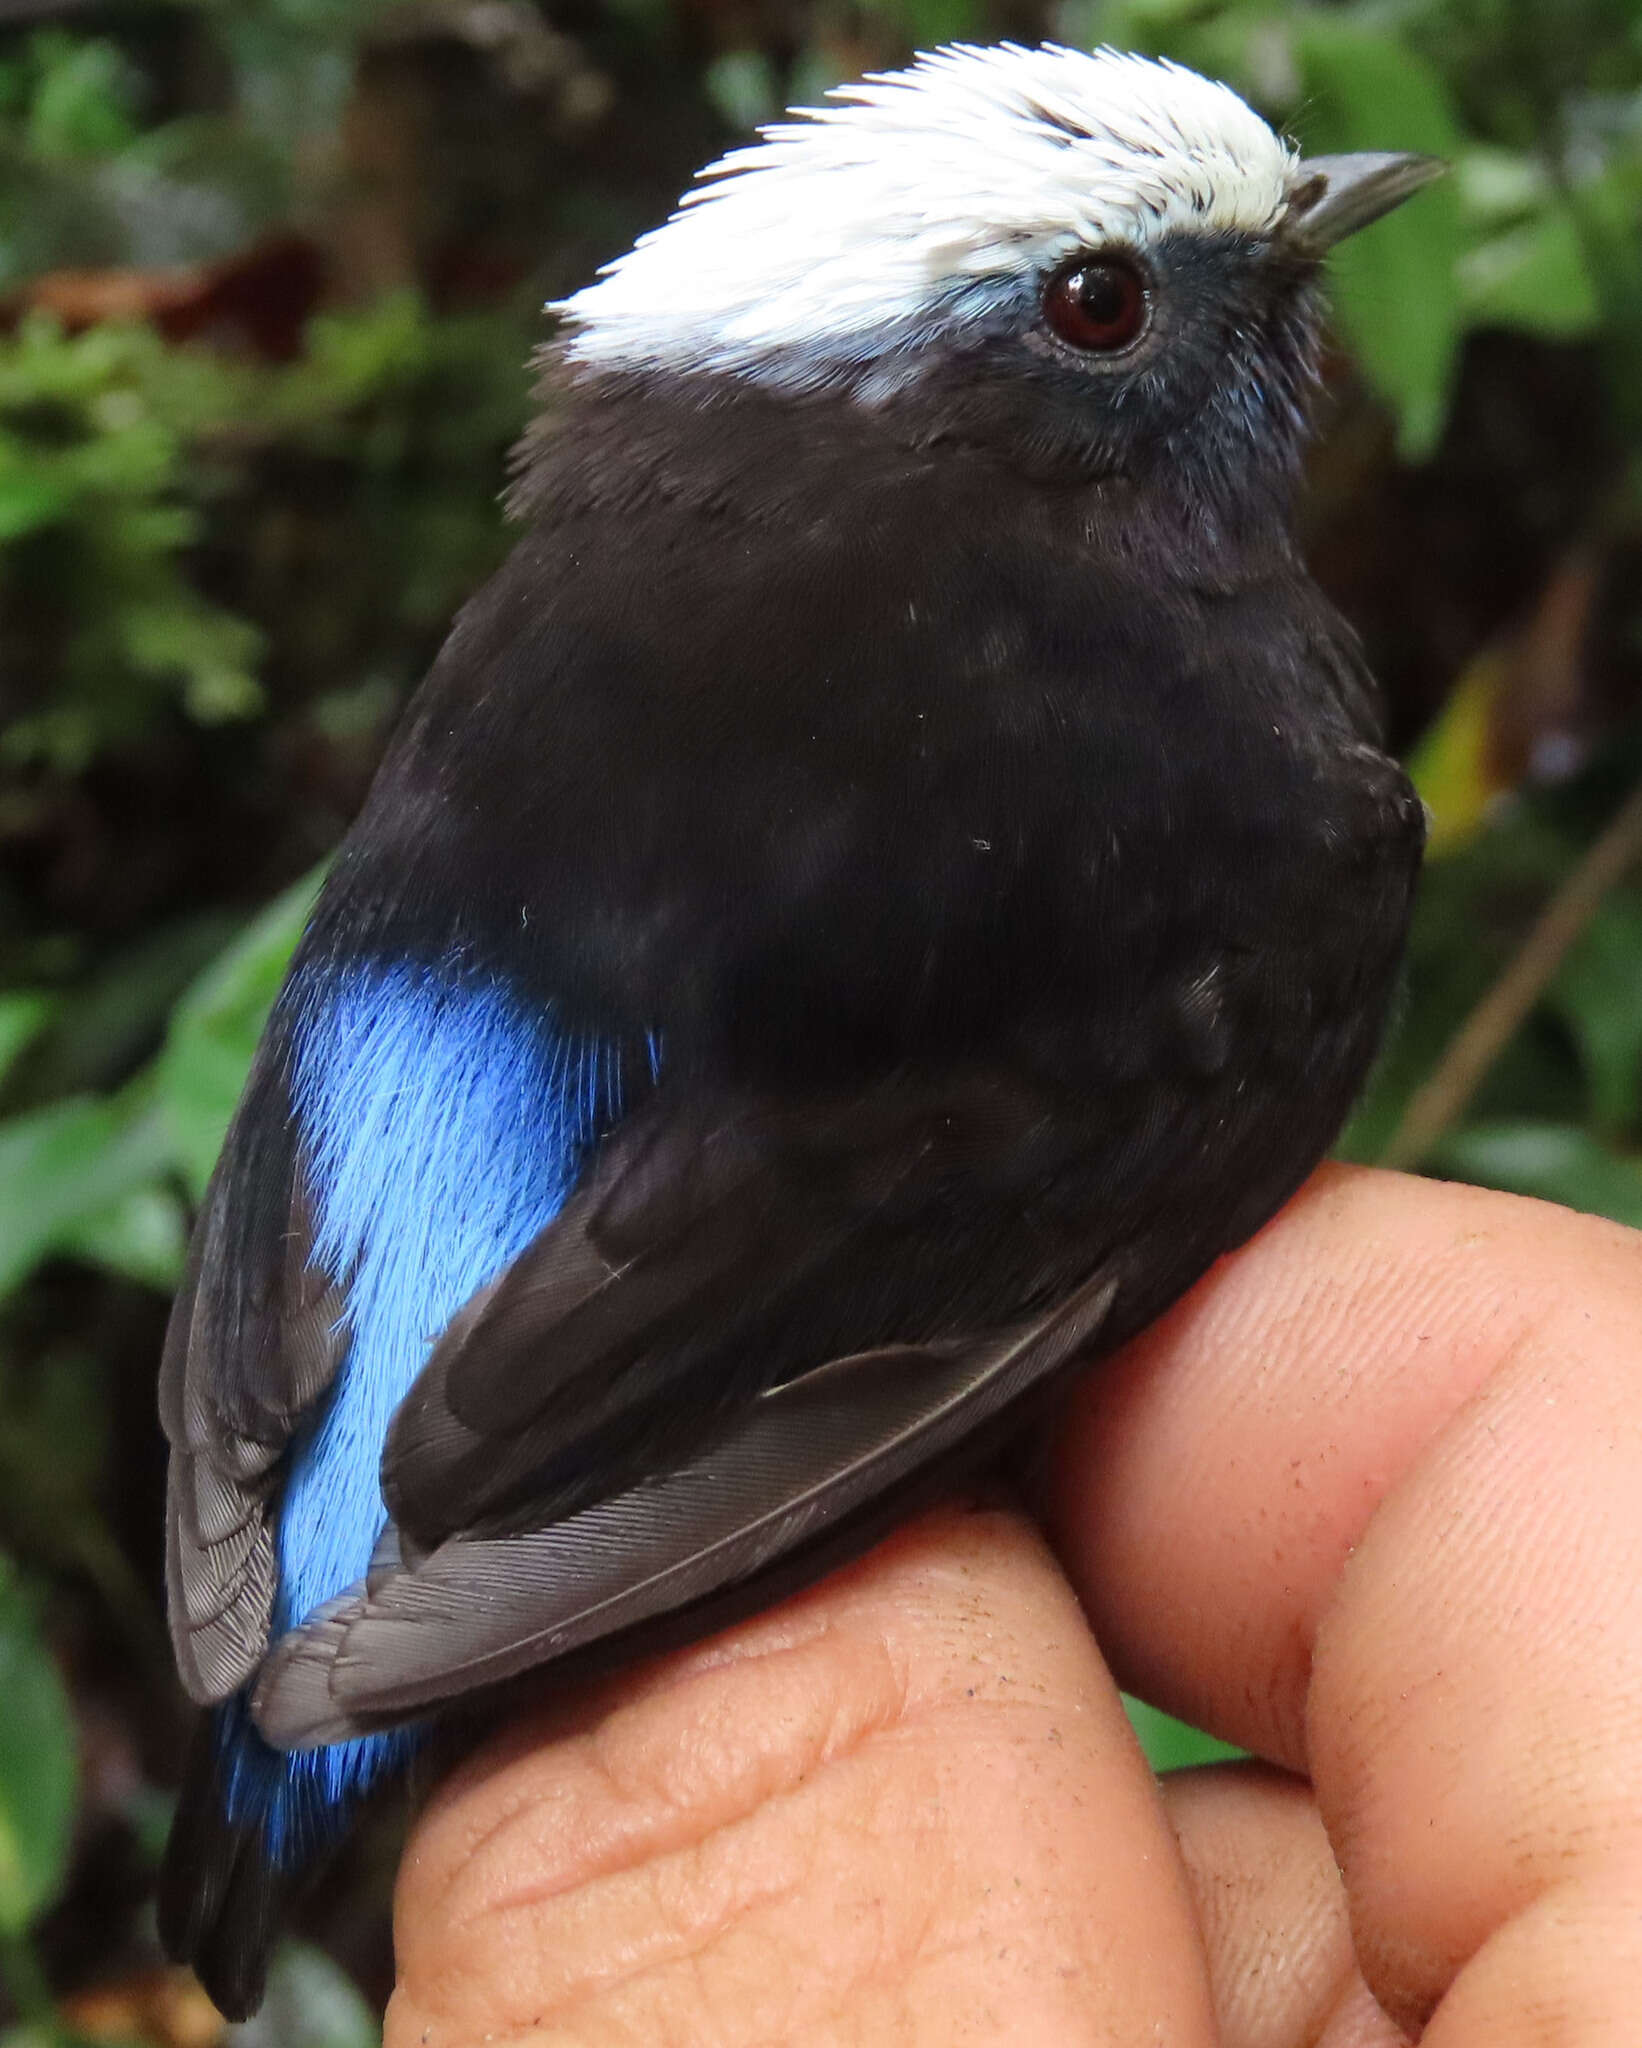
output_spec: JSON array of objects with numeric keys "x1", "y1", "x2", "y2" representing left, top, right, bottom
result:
[{"x1": 0, "y1": 1559, "x2": 76, "y2": 1935}]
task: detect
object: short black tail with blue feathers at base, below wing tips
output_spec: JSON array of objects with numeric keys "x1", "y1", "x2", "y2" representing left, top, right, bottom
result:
[{"x1": 160, "y1": 1694, "x2": 416, "y2": 2019}]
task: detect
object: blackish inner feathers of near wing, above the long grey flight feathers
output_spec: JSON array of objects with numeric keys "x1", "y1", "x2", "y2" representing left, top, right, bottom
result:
[{"x1": 383, "y1": 1071, "x2": 1079, "y2": 1552}]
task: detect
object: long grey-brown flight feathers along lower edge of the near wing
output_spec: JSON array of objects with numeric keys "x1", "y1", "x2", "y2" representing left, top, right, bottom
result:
[{"x1": 252, "y1": 1274, "x2": 1118, "y2": 1747}]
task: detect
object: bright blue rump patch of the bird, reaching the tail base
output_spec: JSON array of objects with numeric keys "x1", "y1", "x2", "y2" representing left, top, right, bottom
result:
[{"x1": 217, "y1": 965, "x2": 622, "y2": 1860}]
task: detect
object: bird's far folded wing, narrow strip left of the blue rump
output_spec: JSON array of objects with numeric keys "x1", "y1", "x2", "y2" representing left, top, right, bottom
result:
[{"x1": 160, "y1": 1032, "x2": 344, "y2": 1706}]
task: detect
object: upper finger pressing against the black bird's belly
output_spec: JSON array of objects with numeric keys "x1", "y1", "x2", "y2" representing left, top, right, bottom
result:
[{"x1": 1052, "y1": 1167, "x2": 1642, "y2": 1774}]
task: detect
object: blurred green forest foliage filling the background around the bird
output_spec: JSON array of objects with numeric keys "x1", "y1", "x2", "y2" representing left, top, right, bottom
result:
[{"x1": 0, "y1": 0, "x2": 1642, "y2": 2048}]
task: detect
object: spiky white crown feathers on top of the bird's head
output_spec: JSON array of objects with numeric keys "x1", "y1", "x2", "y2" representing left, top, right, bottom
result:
[{"x1": 551, "y1": 43, "x2": 1296, "y2": 385}]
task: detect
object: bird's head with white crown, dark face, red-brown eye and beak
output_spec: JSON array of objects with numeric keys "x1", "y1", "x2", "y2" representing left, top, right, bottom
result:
[{"x1": 555, "y1": 45, "x2": 1439, "y2": 512}]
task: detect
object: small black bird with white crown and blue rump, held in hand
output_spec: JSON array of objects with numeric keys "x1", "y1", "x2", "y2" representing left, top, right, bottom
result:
[{"x1": 160, "y1": 43, "x2": 1439, "y2": 2017}]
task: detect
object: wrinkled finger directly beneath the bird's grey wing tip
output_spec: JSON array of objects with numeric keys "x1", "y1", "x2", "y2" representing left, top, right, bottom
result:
[{"x1": 387, "y1": 1511, "x2": 1214, "y2": 2048}]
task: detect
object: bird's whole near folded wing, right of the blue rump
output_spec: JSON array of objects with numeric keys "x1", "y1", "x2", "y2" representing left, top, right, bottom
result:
[{"x1": 254, "y1": 1085, "x2": 1118, "y2": 1745}]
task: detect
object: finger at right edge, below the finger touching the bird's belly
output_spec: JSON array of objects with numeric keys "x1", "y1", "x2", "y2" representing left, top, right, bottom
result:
[{"x1": 1308, "y1": 1286, "x2": 1642, "y2": 2048}]
